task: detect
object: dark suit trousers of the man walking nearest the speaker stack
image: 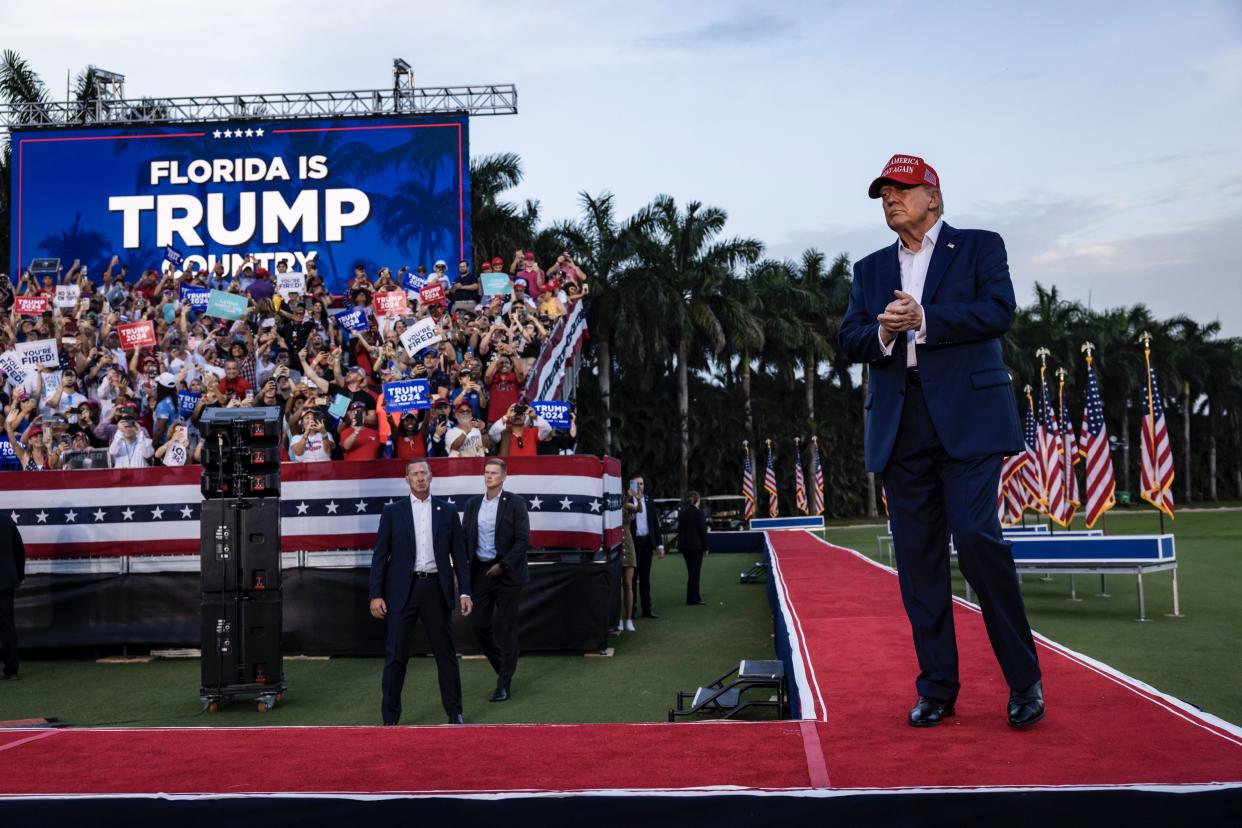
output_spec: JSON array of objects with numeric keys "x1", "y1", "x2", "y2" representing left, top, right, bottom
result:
[{"x1": 380, "y1": 577, "x2": 462, "y2": 725}]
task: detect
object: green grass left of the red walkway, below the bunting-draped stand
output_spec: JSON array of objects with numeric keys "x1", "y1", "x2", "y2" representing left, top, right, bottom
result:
[{"x1": 0, "y1": 555, "x2": 773, "y2": 726}]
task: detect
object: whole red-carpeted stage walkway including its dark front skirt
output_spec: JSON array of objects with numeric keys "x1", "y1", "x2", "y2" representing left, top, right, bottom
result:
[{"x1": 0, "y1": 531, "x2": 1242, "y2": 826}]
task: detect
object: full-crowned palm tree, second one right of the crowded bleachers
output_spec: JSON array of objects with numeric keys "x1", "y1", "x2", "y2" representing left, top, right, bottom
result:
[{"x1": 631, "y1": 195, "x2": 763, "y2": 494}]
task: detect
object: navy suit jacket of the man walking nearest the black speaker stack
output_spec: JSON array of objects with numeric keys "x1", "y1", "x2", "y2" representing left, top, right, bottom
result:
[{"x1": 370, "y1": 495, "x2": 469, "y2": 616}]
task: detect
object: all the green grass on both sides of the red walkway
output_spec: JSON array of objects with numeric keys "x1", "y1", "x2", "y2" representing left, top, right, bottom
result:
[{"x1": 0, "y1": 510, "x2": 1242, "y2": 726}]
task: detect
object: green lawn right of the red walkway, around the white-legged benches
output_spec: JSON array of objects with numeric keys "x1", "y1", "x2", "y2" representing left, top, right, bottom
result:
[{"x1": 827, "y1": 509, "x2": 1242, "y2": 722}]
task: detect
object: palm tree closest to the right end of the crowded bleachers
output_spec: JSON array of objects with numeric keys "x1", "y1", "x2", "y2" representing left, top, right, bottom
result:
[{"x1": 550, "y1": 192, "x2": 650, "y2": 453}]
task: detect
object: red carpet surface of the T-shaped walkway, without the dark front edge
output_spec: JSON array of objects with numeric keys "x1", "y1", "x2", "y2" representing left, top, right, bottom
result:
[{"x1": 0, "y1": 533, "x2": 1242, "y2": 797}]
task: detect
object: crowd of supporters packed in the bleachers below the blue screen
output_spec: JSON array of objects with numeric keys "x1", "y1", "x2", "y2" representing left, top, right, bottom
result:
[{"x1": 0, "y1": 245, "x2": 589, "y2": 470}]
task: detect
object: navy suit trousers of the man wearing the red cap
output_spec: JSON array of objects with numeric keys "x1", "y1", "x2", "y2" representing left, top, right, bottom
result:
[{"x1": 884, "y1": 382, "x2": 1040, "y2": 701}]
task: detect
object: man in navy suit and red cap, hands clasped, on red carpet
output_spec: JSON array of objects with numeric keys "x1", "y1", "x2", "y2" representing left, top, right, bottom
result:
[{"x1": 840, "y1": 155, "x2": 1045, "y2": 727}]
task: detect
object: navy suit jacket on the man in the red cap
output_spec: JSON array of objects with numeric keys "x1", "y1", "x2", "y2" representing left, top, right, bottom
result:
[{"x1": 838, "y1": 225, "x2": 1023, "y2": 472}]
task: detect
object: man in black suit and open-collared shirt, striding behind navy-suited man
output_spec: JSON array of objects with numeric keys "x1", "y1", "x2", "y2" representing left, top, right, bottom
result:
[{"x1": 466, "y1": 457, "x2": 530, "y2": 701}]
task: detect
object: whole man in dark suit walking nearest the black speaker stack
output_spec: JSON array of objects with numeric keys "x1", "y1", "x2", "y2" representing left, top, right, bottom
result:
[{"x1": 370, "y1": 458, "x2": 473, "y2": 725}]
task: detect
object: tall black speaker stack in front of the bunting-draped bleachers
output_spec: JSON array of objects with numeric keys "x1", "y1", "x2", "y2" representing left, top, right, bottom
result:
[{"x1": 199, "y1": 407, "x2": 284, "y2": 713}]
